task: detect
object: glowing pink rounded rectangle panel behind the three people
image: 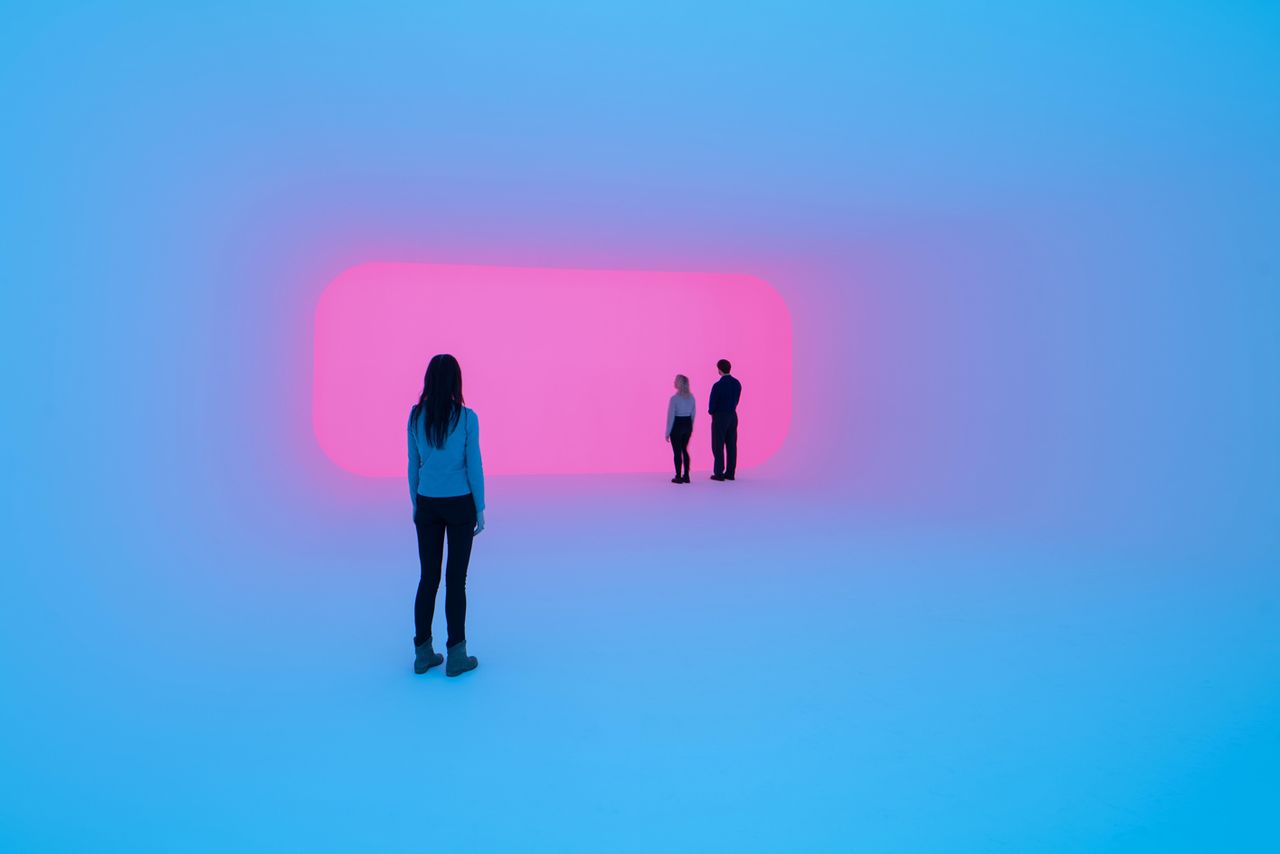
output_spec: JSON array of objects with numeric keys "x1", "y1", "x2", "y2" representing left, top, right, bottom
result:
[{"x1": 312, "y1": 264, "x2": 791, "y2": 478}]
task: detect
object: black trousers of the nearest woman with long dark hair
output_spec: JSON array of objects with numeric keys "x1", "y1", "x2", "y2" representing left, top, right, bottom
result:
[{"x1": 413, "y1": 494, "x2": 476, "y2": 647}]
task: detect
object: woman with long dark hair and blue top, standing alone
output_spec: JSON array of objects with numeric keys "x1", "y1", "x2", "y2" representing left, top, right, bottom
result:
[{"x1": 408, "y1": 353, "x2": 484, "y2": 676}]
